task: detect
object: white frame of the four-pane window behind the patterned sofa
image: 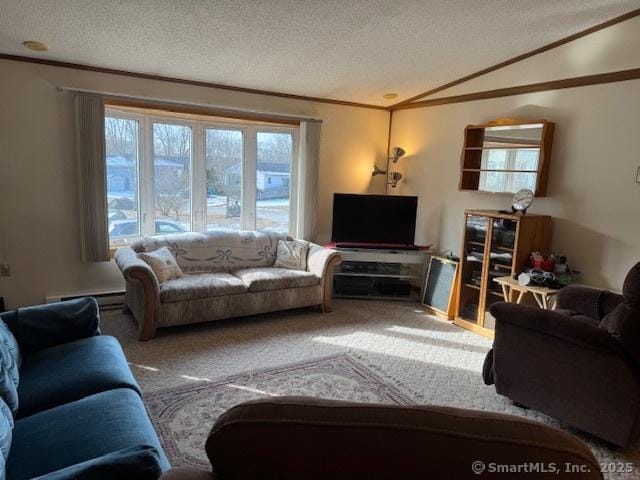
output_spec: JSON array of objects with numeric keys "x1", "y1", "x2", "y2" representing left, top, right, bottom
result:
[{"x1": 105, "y1": 105, "x2": 300, "y2": 247}]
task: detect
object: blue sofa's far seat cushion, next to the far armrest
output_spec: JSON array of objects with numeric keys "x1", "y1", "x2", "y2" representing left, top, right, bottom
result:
[{"x1": 17, "y1": 335, "x2": 140, "y2": 418}]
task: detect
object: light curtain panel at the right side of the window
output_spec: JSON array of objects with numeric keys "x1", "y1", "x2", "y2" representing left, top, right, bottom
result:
[{"x1": 296, "y1": 121, "x2": 322, "y2": 241}]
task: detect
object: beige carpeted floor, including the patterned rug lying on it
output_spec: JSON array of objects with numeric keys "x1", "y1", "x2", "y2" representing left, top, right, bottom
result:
[{"x1": 103, "y1": 300, "x2": 640, "y2": 479}]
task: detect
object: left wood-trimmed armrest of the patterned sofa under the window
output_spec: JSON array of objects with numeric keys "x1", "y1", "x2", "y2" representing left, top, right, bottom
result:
[{"x1": 114, "y1": 246, "x2": 160, "y2": 340}]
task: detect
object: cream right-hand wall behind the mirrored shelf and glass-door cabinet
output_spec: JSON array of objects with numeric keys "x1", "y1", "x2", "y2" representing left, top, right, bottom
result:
[{"x1": 392, "y1": 18, "x2": 640, "y2": 290}]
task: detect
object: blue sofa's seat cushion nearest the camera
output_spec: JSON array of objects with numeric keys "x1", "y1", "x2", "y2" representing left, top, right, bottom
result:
[{"x1": 7, "y1": 388, "x2": 169, "y2": 480}]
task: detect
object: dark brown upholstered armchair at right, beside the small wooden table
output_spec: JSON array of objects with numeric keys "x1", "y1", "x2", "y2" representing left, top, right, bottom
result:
[{"x1": 484, "y1": 263, "x2": 640, "y2": 448}]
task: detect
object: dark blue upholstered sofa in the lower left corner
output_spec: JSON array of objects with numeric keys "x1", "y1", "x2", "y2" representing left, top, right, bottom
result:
[{"x1": 0, "y1": 298, "x2": 169, "y2": 480}]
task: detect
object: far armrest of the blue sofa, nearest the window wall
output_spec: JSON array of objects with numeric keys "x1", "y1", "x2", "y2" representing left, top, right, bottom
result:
[{"x1": 5, "y1": 297, "x2": 100, "y2": 356}]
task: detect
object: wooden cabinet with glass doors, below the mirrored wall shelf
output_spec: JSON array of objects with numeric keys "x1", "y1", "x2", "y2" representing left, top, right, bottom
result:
[{"x1": 454, "y1": 210, "x2": 551, "y2": 338}]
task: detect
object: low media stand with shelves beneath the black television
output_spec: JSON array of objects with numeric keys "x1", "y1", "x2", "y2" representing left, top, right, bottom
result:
[{"x1": 333, "y1": 247, "x2": 430, "y2": 301}]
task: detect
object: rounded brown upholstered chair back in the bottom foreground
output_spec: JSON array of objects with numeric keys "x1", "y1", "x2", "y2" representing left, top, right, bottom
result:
[{"x1": 161, "y1": 397, "x2": 602, "y2": 480}]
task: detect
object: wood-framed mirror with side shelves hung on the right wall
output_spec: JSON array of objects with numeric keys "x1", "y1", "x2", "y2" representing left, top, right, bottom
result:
[{"x1": 459, "y1": 119, "x2": 554, "y2": 197}]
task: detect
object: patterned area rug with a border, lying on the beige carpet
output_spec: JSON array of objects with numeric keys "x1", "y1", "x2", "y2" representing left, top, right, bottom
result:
[{"x1": 145, "y1": 354, "x2": 415, "y2": 467}]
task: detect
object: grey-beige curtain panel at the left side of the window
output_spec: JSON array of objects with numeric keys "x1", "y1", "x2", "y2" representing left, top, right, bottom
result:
[{"x1": 74, "y1": 93, "x2": 110, "y2": 262}]
